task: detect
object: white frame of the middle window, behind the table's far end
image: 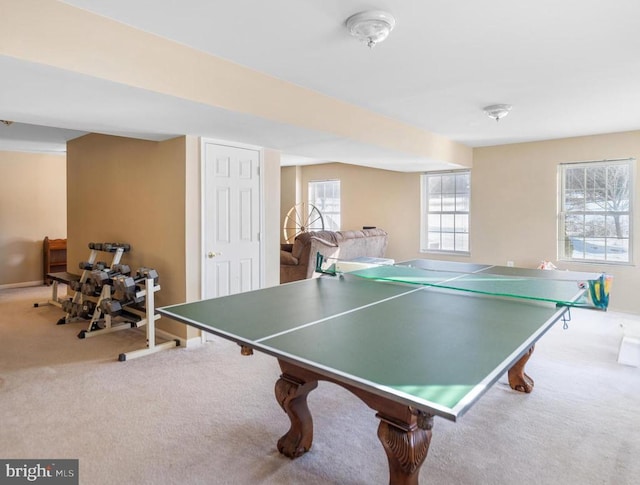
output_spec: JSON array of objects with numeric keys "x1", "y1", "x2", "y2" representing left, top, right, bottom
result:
[{"x1": 420, "y1": 170, "x2": 471, "y2": 256}]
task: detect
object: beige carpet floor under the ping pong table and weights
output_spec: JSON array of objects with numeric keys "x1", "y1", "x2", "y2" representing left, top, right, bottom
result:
[{"x1": 0, "y1": 287, "x2": 640, "y2": 485}]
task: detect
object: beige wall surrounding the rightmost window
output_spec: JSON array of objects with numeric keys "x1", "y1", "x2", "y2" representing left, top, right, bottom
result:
[{"x1": 471, "y1": 131, "x2": 640, "y2": 313}]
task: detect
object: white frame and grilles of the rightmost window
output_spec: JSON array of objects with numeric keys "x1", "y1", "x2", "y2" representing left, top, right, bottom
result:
[{"x1": 558, "y1": 158, "x2": 635, "y2": 265}]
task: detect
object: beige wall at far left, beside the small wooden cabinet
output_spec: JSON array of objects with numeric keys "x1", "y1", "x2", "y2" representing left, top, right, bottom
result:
[{"x1": 0, "y1": 151, "x2": 67, "y2": 287}]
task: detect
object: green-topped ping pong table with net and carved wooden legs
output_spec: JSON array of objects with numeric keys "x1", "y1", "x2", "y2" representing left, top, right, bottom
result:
[{"x1": 158, "y1": 260, "x2": 608, "y2": 484}]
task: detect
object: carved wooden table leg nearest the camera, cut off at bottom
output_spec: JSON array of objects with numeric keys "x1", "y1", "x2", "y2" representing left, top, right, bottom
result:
[{"x1": 377, "y1": 412, "x2": 433, "y2": 485}]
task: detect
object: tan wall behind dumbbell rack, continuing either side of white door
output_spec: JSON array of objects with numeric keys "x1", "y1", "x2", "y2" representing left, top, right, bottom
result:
[{"x1": 67, "y1": 134, "x2": 280, "y2": 339}]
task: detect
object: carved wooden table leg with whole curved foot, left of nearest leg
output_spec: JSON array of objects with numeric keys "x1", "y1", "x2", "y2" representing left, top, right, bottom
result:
[{"x1": 275, "y1": 374, "x2": 318, "y2": 458}]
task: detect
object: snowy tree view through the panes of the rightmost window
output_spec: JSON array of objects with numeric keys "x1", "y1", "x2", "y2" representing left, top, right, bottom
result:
[{"x1": 559, "y1": 160, "x2": 632, "y2": 262}]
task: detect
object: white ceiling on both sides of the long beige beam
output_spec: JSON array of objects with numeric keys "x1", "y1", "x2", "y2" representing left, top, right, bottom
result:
[{"x1": 0, "y1": 0, "x2": 640, "y2": 170}]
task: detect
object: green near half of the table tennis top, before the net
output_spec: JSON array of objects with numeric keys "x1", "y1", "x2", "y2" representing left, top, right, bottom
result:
[{"x1": 158, "y1": 266, "x2": 582, "y2": 420}]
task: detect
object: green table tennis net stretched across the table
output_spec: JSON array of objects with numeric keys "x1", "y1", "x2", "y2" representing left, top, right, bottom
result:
[{"x1": 316, "y1": 251, "x2": 612, "y2": 310}]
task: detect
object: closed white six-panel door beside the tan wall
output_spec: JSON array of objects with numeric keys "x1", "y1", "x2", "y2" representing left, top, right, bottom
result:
[{"x1": 202, "y1": 142, "x2": 260, "y2": 298}]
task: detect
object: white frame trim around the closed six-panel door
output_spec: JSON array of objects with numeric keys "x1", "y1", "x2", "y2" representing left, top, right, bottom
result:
[{"x1": 200, "y1": 138, "x2": 265, "y2": 302}]
